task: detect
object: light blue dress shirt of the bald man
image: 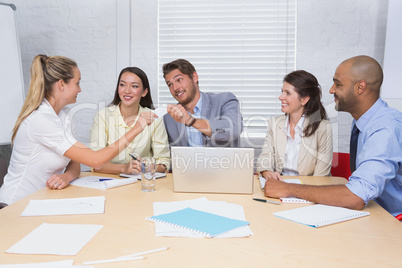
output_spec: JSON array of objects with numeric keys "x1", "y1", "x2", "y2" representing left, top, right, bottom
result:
[{"x1": 346, "y1": 98, "x2": 402, "y2": 216}]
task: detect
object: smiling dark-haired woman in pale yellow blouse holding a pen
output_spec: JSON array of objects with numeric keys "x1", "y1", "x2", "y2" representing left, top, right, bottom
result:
[{"x1": 90, "y1": 67, "x2": 170, "y2": 174}]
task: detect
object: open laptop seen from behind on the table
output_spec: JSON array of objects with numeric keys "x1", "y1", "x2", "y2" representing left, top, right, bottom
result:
[{"x1": 171, "y1": 147, "x2": 254, "y2": 194}]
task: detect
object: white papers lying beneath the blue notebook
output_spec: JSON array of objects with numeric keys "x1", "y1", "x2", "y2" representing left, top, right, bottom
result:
[{"x1": 149, "y1": 197, "x2": 254, "y2": 237}]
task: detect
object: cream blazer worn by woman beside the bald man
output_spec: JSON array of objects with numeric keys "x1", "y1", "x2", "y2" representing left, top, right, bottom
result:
[{"x1": 257, "y1": 115, "x2": 332, "y2": 176}]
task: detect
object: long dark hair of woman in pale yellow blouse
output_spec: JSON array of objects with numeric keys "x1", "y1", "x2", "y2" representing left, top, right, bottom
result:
[{"x1": 109, "y1": 67, "x2": 154, "y2": 109}]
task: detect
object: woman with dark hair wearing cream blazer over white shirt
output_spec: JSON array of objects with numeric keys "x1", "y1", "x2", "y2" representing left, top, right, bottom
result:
[{"x1": 257, "y1": 70, "x2": 332, "y2": 180}]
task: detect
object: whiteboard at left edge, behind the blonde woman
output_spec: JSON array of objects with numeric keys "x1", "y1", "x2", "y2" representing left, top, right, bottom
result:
[{"x1": 0, "y1": 3, "x2": 25, "y2": 144}]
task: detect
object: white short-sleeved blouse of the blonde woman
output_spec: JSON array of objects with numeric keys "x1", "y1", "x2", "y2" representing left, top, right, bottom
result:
[{"x1": 0, "y1": 99, "x2": 77, "y2": 204}]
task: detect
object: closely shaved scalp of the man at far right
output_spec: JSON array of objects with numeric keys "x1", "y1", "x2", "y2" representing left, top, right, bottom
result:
[{"x1": 341, "y1": 55, "x2": 383, "y2": 95}]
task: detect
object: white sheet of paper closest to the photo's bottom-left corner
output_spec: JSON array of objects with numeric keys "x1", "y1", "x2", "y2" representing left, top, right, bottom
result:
[{"x1": 6, "y1": 223, "x2": 103, "y2": 255}]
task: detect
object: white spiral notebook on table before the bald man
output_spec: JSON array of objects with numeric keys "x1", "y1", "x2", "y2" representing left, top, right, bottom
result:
[{"x1": 274, "y1": 204, "x2": 370, "y2": 227}]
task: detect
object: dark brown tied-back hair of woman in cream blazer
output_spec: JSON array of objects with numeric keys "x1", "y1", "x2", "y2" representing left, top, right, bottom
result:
[{"x1": 283, "y1": 70, "x2": 328, "y2": 137}]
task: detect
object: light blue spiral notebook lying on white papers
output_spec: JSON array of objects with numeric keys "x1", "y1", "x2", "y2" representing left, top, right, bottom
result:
[{"x1": 146, "y1": 208, "x2": 249, "y2": 238}]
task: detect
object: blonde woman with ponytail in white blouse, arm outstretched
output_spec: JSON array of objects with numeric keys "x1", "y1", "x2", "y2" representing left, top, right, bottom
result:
[{"x1": 0, "y1": 55, "x2": 155, "y2": 204}]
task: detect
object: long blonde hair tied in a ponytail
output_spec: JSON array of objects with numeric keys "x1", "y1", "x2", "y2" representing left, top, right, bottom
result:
[{"x1": 11, "y1": 55, "x2": 77, "y2": 142}]
